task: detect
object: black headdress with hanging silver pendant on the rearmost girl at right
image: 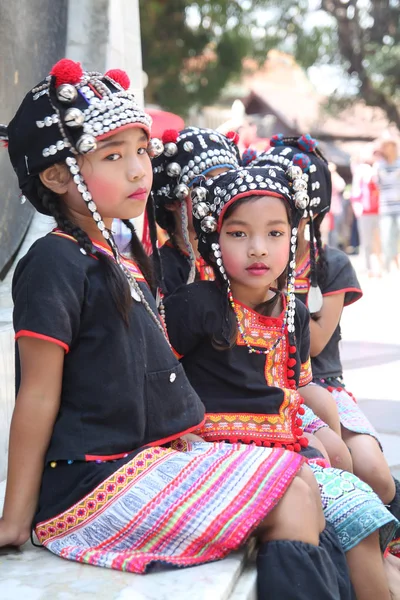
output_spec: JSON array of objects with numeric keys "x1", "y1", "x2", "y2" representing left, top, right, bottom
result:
[{"x1": 252, "y1": 134, "x2": 332, "y2": 313}]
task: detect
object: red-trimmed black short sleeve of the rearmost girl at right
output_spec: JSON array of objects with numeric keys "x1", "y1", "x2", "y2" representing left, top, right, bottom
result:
[{"x1": 321, "y1": 247, "x2": 362, "y2": 306}]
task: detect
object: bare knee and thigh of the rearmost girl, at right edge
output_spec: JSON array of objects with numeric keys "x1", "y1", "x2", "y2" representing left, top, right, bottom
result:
[{"x1": 342, "y1": 427, "x2": 396, "y2": 504}]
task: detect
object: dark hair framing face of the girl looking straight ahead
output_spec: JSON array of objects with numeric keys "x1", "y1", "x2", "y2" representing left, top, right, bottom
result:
[{"x1": 207, "y1": 193, "x2": 291, "y2": 350}]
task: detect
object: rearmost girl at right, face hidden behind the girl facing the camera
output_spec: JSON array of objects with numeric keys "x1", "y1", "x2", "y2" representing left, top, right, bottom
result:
[{"x1": 256, "y1": 135, "x2": 400, "y2": 549}]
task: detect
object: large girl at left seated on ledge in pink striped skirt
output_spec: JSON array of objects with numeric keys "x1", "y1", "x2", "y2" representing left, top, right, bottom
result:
[{"x1": 0, "y1": 60, "x2": 354, "y2": 600}]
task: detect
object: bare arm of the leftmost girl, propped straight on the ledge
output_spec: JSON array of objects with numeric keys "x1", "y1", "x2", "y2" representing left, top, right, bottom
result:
[{"x1": 0, "y1": 337, "x2": 65, "y2": 546}]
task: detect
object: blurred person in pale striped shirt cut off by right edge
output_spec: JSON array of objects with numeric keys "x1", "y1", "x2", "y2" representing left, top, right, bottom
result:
[{"x1": 375, "y1": 138, "x2": 400, "y2": 272}]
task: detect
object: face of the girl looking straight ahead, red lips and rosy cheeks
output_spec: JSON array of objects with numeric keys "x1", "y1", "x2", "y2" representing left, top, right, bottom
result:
[{"x1": 219, "y1": 196, "x2": 291, "y2": 303}]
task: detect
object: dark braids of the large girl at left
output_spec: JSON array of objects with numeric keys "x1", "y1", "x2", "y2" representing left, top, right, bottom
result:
[{"x1": 22, "y1": 176, "x2": 154, "y2": 325}]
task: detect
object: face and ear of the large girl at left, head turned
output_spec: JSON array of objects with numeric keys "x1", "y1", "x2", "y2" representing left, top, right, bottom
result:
[{"x1": 64, "y1": 127, "x2": 153, "y2": 220}]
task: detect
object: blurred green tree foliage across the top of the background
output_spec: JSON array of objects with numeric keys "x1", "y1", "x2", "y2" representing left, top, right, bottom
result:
[{"x1": 140, "y1": 0, "x2": 400, "y2": 128}]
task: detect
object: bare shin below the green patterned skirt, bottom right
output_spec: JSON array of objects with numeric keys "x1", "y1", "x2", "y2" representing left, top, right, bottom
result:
[{"x1": 346, "y1": 531, "x2": 391, "y2": 600}]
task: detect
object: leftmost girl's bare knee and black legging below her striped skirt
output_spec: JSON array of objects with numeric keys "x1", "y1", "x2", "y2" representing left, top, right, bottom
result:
[{"x1": 257, "y1": 466, "x2": 352, "y2": 600}]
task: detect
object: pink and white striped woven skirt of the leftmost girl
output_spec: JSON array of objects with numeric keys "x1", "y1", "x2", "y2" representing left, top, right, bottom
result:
[{"x1": 35, "y1": 440, "x2": 303, "y2": 573}]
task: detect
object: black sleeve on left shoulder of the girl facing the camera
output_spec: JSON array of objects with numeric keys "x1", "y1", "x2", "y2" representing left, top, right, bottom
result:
[{"x1": 165, "y1": 281, "x2": 223, "y2": 356}]
